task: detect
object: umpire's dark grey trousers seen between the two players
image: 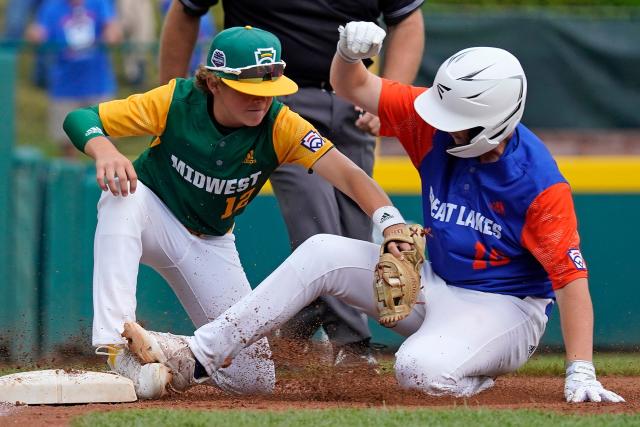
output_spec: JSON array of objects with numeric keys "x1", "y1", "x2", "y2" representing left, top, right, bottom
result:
[{"x1": 270, "y1": 87, "x2": 375, "y2": 346}]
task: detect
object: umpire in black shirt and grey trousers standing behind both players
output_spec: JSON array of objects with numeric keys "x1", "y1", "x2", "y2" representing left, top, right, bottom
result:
[{"x1": 160, "y1": 0, "x2": 424, "y2": 365}]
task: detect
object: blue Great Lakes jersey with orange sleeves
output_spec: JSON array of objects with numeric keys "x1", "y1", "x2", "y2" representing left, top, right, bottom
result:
[{"x1": 379, "y1": 81, "x2": 587, "y2": 298}]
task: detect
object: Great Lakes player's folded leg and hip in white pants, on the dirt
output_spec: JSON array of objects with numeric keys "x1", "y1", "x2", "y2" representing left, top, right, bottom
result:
[{"x1": 395, "y1": 264, "x2": 550, "y2": 396}]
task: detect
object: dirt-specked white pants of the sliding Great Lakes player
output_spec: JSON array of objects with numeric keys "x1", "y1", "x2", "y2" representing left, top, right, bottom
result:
[{"x1": 190, "y1": 234, "x2": 551, "y2": 396}]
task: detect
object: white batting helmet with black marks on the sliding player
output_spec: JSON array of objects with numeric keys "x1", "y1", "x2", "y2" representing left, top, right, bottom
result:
[{"x1": 414, "y1": 47, "x2": 527, "y2": 158}]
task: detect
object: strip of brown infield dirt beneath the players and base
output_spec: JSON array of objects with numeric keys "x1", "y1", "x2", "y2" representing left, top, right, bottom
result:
[{"x1": 0, "y1": 369, "x2": 640, "y2": 427}]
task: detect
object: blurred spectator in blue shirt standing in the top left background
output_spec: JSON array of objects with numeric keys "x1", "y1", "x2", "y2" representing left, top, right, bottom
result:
[{"x1": 27, "y1": 0, "x2": 121, "y2": 158}]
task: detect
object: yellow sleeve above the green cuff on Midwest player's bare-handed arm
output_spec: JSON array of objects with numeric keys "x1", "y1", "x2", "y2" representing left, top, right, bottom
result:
[{"x1": 98, "y1": 79, "x2": 176, "y2": 136}]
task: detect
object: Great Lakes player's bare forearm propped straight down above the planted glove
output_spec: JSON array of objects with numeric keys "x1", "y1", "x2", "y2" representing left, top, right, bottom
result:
[{"x1": 556, "y1": 279, "x2": 593, "y2": 361}]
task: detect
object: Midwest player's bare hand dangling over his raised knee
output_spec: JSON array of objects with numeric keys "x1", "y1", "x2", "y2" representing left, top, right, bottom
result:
[{"x1": 85, "y1": 136, "x2": 138, "y2": 197}]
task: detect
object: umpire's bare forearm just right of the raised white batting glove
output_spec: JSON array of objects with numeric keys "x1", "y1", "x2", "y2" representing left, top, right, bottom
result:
[{"x1": 381, "y1": 9, "x2": 425, "y2": 84}]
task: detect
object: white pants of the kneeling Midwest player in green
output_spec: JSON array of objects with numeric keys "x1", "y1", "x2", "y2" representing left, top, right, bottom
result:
[{"x1": 93, "y1": 182, "x2": 275, "y2": 394}]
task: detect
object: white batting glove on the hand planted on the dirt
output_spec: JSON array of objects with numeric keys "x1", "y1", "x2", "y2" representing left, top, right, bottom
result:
[{"x1": 564, "y1": 360, "x2": 625, "y2": 403}]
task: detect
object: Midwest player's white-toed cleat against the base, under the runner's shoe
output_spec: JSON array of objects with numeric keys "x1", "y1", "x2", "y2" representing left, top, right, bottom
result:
[{"x1": 96, "y1": 345, "x2": 171, "y2": 399}]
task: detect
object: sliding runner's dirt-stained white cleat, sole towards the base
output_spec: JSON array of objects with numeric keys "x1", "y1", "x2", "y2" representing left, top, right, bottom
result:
[{"x1": 122, "y1": 322, "x2": 202, "y2": 391}]
